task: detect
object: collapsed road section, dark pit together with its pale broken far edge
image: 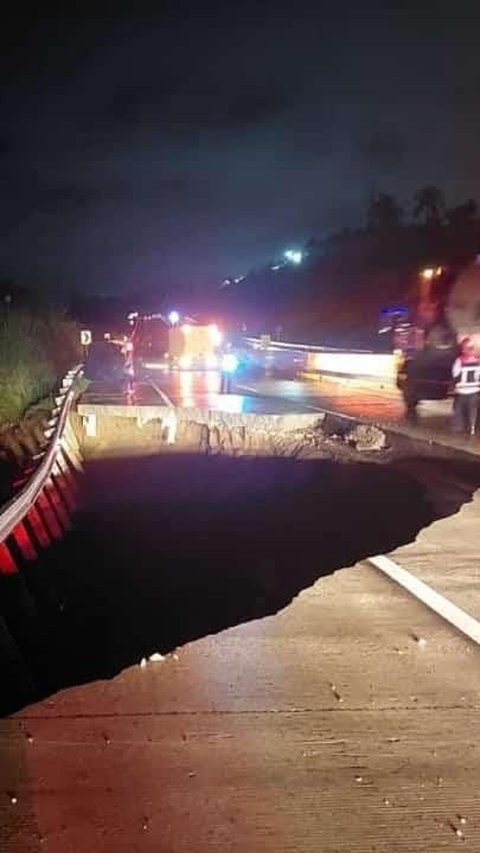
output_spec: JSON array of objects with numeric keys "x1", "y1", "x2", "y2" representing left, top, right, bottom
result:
[{"x1": 0, "y1": 386, "x2": 480, "y2": 713}]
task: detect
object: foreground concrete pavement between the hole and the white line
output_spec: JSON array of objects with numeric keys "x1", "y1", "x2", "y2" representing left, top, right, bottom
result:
[{"x1": 0, "y1": 544, "x2": 480, "y2": 853}]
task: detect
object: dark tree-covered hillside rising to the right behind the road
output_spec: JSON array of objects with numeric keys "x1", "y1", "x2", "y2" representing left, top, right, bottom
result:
[{"x1": 219, "y1": 186, "x2": 480, "y2": 346}]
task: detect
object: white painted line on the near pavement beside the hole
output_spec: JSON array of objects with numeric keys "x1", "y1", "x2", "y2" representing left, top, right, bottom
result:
[{"x1": 366, "y1": 554, "x2": 480, "y2": 645}]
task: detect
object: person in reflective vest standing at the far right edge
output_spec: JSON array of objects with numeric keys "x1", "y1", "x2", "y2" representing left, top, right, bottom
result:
[{"x1": 452, "y1": 338, "x2": 480, "y2": 435}]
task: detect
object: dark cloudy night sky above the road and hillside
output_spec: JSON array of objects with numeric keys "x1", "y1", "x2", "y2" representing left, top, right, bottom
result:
[{"x1": 0, "y1": 0, "x2": 480, "y2": 294}]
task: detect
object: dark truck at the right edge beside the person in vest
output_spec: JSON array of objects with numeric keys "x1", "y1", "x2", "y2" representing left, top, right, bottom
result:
[{"x1": 397, "y1": 256, "x2": 480, "y2": 414}]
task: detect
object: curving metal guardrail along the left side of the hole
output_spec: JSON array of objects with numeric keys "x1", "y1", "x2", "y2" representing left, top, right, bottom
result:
[{"x1": 0, "y1": 365, "x2": 83, "y2": 573}]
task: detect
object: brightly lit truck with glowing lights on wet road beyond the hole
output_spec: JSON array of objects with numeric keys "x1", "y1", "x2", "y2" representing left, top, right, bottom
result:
[{"x1": 131, "y1": 314, "x2": 222, "y2": 375}]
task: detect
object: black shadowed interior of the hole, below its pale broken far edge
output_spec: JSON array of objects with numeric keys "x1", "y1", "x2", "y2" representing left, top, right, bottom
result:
[{"x1": 1, "y1": 412, "x2": 480, "y2": 713}]
